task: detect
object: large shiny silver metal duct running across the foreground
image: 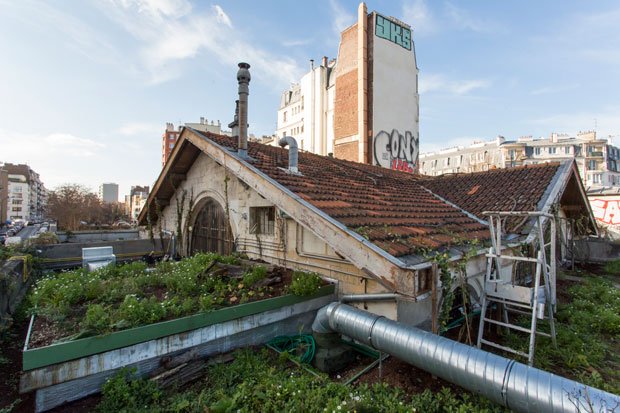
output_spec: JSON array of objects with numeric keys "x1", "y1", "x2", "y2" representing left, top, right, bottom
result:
[{"x1": 312, "y1": 303, "x2": 620, "y2": 413}]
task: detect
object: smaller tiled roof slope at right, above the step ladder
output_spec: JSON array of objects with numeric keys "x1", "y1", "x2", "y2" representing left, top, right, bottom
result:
[{"x1": 420, "y1": 163, "x2": 560, "y2": 230}]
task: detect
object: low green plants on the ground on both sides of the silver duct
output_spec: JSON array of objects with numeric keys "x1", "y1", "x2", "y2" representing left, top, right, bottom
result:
[{"x1": 98, "y1": 266, "x2": 620, "y2": 412}]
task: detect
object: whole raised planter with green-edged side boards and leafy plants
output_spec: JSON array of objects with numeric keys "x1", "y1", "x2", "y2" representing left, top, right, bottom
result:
[{"x1": 20, "y1": 254, "x2": 334, "y2": 411}]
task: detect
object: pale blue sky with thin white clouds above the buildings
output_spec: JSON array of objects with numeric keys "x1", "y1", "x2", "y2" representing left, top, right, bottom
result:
[{"x1": 0, "y1": 0, "x2": 620, "y2": 199}]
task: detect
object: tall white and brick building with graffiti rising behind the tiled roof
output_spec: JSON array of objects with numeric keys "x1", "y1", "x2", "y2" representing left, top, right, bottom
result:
[{"x1": 273, "y1": 3, "x2": 419, "y2": 172}]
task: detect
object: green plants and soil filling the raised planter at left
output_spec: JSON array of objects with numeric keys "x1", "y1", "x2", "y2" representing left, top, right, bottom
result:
[{"x1": 29, "y1": 253, "x2": 321, "y2": 347}]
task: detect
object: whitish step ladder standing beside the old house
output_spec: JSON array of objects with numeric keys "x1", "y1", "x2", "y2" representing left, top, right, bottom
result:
[{"x1": 477, "y1": 211, "x2": 556, "y2": 366}]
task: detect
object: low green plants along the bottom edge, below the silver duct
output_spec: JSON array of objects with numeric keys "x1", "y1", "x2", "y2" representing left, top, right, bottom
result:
[{"x1": 98, "y1": 349, "x2": 503, "y2": 413}]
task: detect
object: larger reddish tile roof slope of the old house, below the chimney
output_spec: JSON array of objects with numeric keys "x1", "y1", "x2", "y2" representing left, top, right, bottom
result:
[{"x1": 198, "y1": 132, "x2": 489, "y2": 257}]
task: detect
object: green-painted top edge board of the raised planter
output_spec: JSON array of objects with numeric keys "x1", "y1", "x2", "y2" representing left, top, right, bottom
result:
[{"x1": 22, "y1": 285, "x2": 334, "y2": 371}]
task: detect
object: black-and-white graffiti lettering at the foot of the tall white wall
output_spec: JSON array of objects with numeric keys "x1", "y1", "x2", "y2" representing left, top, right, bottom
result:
[{"x1": 373, "y1": 129, "x2": 419, "y2": 173}]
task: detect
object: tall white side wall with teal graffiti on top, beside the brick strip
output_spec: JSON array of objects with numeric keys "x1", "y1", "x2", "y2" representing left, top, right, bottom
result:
[{"x1": 369, "y1": 13, "x2": 420, "y2": 173}]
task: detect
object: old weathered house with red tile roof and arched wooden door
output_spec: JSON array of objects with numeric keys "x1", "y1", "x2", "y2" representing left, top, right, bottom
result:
[{"x1": 139, "y1": 128, "x2": 592, "y2": 324}]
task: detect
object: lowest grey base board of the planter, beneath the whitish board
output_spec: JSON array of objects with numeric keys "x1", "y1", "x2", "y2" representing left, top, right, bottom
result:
[{"x1": 35, "y1": 310, "x2": 316, "y2": 412}]
